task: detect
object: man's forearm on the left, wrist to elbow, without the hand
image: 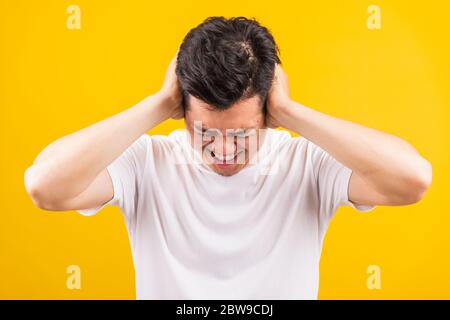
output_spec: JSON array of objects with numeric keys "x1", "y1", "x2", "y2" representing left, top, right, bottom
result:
[{"x1": 25, "y1": 95, "x2": 168, "y2": 199}]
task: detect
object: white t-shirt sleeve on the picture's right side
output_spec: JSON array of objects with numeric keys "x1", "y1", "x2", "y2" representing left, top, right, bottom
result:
[{"x1": 309, "y1": 142, "x2": 375, "y2": 220}]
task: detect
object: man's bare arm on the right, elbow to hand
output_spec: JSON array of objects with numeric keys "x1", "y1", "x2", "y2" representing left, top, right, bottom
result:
[{"x1": 267, "y1": 65, "x2": 432, "y2": 205}]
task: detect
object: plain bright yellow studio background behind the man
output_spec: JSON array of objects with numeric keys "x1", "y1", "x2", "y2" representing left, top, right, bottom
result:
[{"x1": 0, "y1": 0, "x2": 450, "y2": 299}]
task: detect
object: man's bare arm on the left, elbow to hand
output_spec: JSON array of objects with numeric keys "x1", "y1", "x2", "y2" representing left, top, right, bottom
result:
[{"x1": 25, "y1": 52, "x2": 181, "y2": 211}]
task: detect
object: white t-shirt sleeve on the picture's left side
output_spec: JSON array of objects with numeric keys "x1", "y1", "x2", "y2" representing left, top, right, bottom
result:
[{"x1": 76, "y1": 134, "x2": 150, "y2": 218}]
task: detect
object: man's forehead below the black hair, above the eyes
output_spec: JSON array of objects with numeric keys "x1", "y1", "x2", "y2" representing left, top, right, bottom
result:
[{"x1": 185, "y1": 95, "x2": 264, "y2": 129}]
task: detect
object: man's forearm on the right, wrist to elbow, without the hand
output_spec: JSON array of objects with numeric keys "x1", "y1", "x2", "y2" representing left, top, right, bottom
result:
[{"x1": 281, "y1": 102, "x2": 431, "y2": 192}]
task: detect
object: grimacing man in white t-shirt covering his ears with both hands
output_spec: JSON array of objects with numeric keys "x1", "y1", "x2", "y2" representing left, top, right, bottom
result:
[{"x1": 25, "y1": 17, "x2": 431, "y2": 299}]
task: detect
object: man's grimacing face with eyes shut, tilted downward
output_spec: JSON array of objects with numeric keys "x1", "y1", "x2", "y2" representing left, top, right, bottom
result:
[{"x1": 185, "y1": 95, "x2": 264, "y2": 176}]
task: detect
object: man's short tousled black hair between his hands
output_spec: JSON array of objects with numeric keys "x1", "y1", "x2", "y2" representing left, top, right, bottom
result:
[{"x1": 176, "y1": 17, "x2": 281, "y2": 111}]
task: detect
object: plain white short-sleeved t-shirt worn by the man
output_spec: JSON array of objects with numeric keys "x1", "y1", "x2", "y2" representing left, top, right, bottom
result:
[{"x1": 78, "y1": 129, "x2": 375, "y2": 299}]
